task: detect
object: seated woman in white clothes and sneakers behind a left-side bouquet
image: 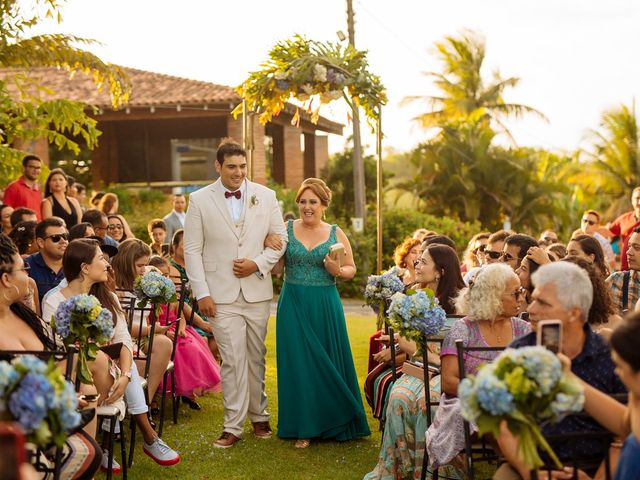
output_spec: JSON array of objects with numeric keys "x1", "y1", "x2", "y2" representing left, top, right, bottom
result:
[{"x1": 42, "y1": 239, "x2": 180, "y2": 471}]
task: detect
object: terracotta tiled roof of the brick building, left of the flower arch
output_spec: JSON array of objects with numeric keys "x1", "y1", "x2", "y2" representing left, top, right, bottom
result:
[{"x1": 0, "y1": 67, "x2": 240, "y2": 108}]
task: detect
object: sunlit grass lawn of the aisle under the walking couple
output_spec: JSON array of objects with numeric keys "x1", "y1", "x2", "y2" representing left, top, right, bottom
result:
[{"x1": 101, "y1": 315, "x2": 380, "y2": 480}]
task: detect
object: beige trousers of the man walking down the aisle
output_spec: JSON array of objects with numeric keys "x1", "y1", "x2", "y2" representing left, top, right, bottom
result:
[{"x1": 209, "y1": 292, "x2": 271, "y2": 437}]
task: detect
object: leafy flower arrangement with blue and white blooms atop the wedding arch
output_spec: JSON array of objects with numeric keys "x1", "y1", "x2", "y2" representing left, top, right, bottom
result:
[{"x1": 233, "y1": 35, "x2": 387, "y2": 128}]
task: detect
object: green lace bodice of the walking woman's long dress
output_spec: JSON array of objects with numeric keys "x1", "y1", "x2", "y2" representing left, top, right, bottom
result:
[{"x1": 284, "y1": 220, "x2": 336, "y2": 287}]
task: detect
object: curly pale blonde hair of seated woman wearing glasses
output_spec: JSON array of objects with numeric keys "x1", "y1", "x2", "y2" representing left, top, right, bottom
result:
[{"x1": 456, "y1": 263, "x2": 518, "y2": 322}]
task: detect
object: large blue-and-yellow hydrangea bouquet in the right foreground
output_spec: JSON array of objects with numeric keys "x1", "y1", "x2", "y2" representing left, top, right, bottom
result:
[{"x1": 458, "y1": 347, "x2": 584, "y2": 469}]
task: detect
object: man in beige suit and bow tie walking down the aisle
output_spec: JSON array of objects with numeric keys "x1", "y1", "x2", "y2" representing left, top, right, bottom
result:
[{"x1": 184, "y1": 139, "x2": 287, "y2": 448}]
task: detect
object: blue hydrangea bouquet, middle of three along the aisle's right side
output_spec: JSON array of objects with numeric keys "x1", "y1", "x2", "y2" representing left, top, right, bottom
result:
[{"x1": 387, "y1": 288, "x2": 447, "y2": 353}]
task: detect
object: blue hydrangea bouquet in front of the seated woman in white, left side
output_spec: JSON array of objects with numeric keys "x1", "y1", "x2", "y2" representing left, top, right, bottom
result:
[{"x1": 51, "y1": 294, "x2": 113, "y2": 384}]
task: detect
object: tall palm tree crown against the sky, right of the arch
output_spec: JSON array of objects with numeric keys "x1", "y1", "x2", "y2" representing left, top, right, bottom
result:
[{"x1": 403, "y1": 31, "x2": 546, "y2": 139}]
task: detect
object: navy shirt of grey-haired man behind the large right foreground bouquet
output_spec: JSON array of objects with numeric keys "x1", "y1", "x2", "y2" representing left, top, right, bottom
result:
[{"x1": 509, "y1": 323, "x2": 627, "y2": 463}]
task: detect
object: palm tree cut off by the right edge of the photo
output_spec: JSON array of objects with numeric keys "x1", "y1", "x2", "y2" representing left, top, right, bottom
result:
[{"x1": 583, "y1": 101, "x2": 640, "y2": 216}]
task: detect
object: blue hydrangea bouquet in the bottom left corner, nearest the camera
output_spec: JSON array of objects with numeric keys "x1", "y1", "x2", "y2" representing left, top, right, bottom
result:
[{"x1": 0, "y1": 355, "x2": 80, "y2": 448}]
